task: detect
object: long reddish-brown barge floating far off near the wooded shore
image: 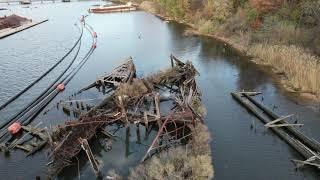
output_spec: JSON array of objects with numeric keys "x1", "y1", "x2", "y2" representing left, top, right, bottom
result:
[{"x1": 89, "y1": 2, "x2": 137, "y2": 13}]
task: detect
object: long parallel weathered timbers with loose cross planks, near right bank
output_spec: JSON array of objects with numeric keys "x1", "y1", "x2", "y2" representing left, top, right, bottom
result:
[{"x1": 231, "y1": 92, "x2": 320, "y2": 168}]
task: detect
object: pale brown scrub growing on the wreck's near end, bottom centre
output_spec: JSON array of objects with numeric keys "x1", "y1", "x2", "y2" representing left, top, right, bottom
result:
[{"x1": 129, "y1": 124, "x2": 214, "y2": 180}]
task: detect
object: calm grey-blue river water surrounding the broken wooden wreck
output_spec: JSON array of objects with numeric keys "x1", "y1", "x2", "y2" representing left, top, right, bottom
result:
[{"x1": 0, "y1": 1, "x2": 320, "y2": 180}]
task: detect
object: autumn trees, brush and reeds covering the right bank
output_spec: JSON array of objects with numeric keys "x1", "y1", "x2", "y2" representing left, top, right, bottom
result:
[{"x1": 123, "y1": 0, "x2": 320, "y2": 97}]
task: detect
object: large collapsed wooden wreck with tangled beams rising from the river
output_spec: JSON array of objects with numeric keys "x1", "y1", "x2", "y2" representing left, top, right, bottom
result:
[{"x1": 49, "y1": 56, "x2": 213, "y2": 179}]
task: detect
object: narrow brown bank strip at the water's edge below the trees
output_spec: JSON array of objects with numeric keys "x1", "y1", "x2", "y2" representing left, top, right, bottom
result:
[{"x1": 139, "y1": 6, "x2": 320, "y2": 104}]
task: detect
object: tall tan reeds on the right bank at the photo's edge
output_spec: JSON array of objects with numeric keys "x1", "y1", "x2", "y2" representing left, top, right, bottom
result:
[{"x1": 249, "y1": 44, "x2": 320, "y2": 94}]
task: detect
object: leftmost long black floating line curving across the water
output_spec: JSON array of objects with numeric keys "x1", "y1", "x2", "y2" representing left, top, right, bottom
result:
[{"x1": 0, "y1": 22, "x2": 83, "y2": 110}]
